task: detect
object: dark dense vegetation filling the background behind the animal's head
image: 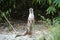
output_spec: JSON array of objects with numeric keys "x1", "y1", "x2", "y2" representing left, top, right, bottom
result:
[{"x1": 0, "y1": 0, "x2": 60, "y2": 24}]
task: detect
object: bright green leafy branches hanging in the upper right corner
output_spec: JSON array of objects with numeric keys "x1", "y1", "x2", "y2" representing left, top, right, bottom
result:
[{"x1": 33, "y1": 0, "x2": 60, "y2": 22}]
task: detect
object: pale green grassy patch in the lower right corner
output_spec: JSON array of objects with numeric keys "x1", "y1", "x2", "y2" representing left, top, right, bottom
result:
[{"x1": 39, "y1": 24, "x2": 60, "y2": 40}]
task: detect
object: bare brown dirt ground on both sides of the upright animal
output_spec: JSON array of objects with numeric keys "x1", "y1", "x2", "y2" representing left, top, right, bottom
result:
[{"x1": 0, "y1": 21, "x2": 48, "y2": 38}]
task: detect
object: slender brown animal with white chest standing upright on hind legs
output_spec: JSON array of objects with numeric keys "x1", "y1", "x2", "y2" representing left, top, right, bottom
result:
[{"x1": 16, "y1": 8, "x2": 34, "y2": 37}]
